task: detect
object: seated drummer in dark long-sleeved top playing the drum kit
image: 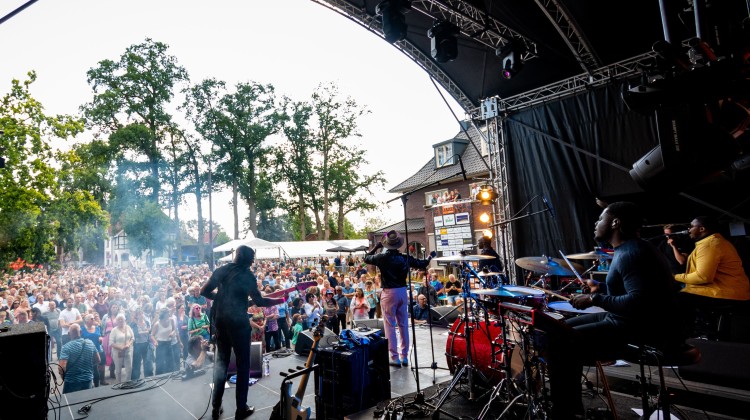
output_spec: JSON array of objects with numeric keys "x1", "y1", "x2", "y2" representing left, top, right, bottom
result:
[{"x1": 548, "y1": 202, "x2": 675, "y2": 419}]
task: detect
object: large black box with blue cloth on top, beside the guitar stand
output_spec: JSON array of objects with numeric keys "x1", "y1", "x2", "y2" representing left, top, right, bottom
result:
[{"x1": 315, "y1": 334, "x2": 391, "y2": 419}]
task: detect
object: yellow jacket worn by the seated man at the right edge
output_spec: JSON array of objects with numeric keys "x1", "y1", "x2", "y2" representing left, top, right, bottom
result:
[{"x1": 674, "y1": 233, "x2": 750, "y2": 300}]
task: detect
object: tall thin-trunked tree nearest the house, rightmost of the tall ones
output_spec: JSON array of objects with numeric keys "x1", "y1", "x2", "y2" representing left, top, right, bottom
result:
[{"x1": 312, "y1": 83, "x2": 369, "y2": 240}]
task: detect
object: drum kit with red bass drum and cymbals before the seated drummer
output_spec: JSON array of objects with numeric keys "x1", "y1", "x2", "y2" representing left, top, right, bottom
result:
[{"x1": 433, "y1": 252, "x2": 611, "y2": 419}]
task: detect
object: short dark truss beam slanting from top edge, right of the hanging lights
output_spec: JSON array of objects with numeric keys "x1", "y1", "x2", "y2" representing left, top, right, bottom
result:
[{"x1": 536, "y1": 0, "x2": 601, "y2": 73}]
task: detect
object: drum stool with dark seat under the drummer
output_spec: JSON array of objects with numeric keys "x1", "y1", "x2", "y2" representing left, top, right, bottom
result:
[{"x1": 626, "y1": 344, "x2": 701, "y2": 419}]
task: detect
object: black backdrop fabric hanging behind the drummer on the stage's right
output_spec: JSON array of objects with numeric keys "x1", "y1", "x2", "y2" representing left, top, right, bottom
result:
[{"x1": 503, "y1": 83, "x2": 750, "y2": 278}]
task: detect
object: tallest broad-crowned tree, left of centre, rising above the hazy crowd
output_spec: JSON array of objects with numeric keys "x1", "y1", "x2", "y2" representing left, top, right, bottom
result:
[{"x1": 82, "y1": 38, "x2": 188, "y2": 202}]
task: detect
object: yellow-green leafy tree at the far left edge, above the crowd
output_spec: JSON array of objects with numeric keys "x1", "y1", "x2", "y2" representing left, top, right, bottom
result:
[{"x1": 0, "y1": 72, "x2": 83, "y2": 263}]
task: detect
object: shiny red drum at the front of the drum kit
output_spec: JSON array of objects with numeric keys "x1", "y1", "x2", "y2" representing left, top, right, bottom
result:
[{"x1": 445, "y1": 317, "x2": 503, "y2": 385}]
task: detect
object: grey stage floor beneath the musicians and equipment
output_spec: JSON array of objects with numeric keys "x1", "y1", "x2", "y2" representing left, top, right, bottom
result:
[{"x1": 48, "y1": 326, "x2": 750, "y2": 420}]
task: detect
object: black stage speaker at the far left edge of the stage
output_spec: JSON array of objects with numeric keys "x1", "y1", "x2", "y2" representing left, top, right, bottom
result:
[{"x1": 0, "y1": 322, "x2": 47, "y2": 420}]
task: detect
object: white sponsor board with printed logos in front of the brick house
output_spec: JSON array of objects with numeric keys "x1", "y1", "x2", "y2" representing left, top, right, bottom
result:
[{"x1": 432, "y1": 202, "x2": 474, "y2": 256}]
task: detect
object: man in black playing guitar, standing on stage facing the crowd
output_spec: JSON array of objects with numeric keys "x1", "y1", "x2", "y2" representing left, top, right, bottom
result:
[{"x1": 201, "y1": 245, "x2": 284, "y2": 419}]
